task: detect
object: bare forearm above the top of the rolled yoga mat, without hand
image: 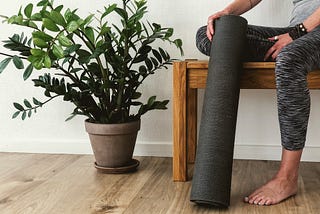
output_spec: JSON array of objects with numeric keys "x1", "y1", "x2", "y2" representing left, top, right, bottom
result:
[{"x1": 223, "y1": 0, "x2": 261, "y2": 15}]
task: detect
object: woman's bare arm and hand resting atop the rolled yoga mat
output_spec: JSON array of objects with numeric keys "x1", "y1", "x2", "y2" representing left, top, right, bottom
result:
[{"x1": 207, "y1": 0, "x2": 262, "y2": 41}]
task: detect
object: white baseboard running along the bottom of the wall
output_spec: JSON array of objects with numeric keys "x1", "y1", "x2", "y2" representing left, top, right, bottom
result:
[{"x1": 0, "y1": 140, "x2": 320, "y2": 162}]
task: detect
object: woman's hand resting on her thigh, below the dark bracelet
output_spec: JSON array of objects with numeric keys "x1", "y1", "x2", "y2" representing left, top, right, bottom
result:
[{"x1": 264, "y1": 33, "x2": 293, "y2": 61}]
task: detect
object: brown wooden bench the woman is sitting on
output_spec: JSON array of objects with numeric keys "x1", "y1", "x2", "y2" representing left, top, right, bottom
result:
[{"x1": 173, "y1": 60, "x2": 320, "y2": 181}]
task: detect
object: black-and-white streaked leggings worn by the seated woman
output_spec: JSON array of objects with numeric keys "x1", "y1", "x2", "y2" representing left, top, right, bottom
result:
[{"x1": 196, "y1": 25, "x2": 320, "y2": 150}]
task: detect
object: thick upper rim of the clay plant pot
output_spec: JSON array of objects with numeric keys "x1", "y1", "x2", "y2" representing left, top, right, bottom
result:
[{"x1": 85, "y1": 119, "x2": 141, "y2": 135}]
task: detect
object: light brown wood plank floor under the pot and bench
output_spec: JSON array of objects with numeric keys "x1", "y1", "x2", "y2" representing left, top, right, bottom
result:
[{"x1": 0, "y1": 153, "x2": 320, "y2": 214}]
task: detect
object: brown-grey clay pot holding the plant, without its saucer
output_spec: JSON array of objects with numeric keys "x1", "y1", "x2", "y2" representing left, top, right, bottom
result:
[{"x1": 85, "y1": 120, "x2": 140, "y2": 169}]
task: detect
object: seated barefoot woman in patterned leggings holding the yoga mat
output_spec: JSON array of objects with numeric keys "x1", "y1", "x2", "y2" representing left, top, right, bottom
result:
[{"x1": 197, "y1": 0, "x2": 320, "y2": 205}]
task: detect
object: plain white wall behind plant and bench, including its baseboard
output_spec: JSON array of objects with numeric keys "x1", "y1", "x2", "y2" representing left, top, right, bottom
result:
[{"x1": 0, "y1": 0, "x2": 320, "y2": 161}]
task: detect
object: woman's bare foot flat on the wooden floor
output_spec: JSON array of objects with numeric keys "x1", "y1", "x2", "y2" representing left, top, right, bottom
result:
[{"x1": 244, "y1": 177, "x2": 298, "y2": 205}]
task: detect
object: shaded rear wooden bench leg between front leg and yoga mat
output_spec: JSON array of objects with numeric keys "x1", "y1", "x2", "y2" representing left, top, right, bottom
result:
[{"x1": 187, "y1": 88, "x2": 198, "y2": 163}]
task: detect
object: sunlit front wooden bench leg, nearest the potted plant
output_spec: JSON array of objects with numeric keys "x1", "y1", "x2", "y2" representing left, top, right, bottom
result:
[{"x1": 173, "y1": 62, "x2": 188, "y2": 181}]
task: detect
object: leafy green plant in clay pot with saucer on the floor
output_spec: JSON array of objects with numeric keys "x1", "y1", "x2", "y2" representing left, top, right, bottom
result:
[{"x1": 0, "y1": 0, "x2": 182, "y2": 173}]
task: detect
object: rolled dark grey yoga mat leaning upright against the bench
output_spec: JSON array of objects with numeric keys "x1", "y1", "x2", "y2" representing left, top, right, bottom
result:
[{"x1": 190, "y1": 15, "x2": 247, "y2": 207}]
